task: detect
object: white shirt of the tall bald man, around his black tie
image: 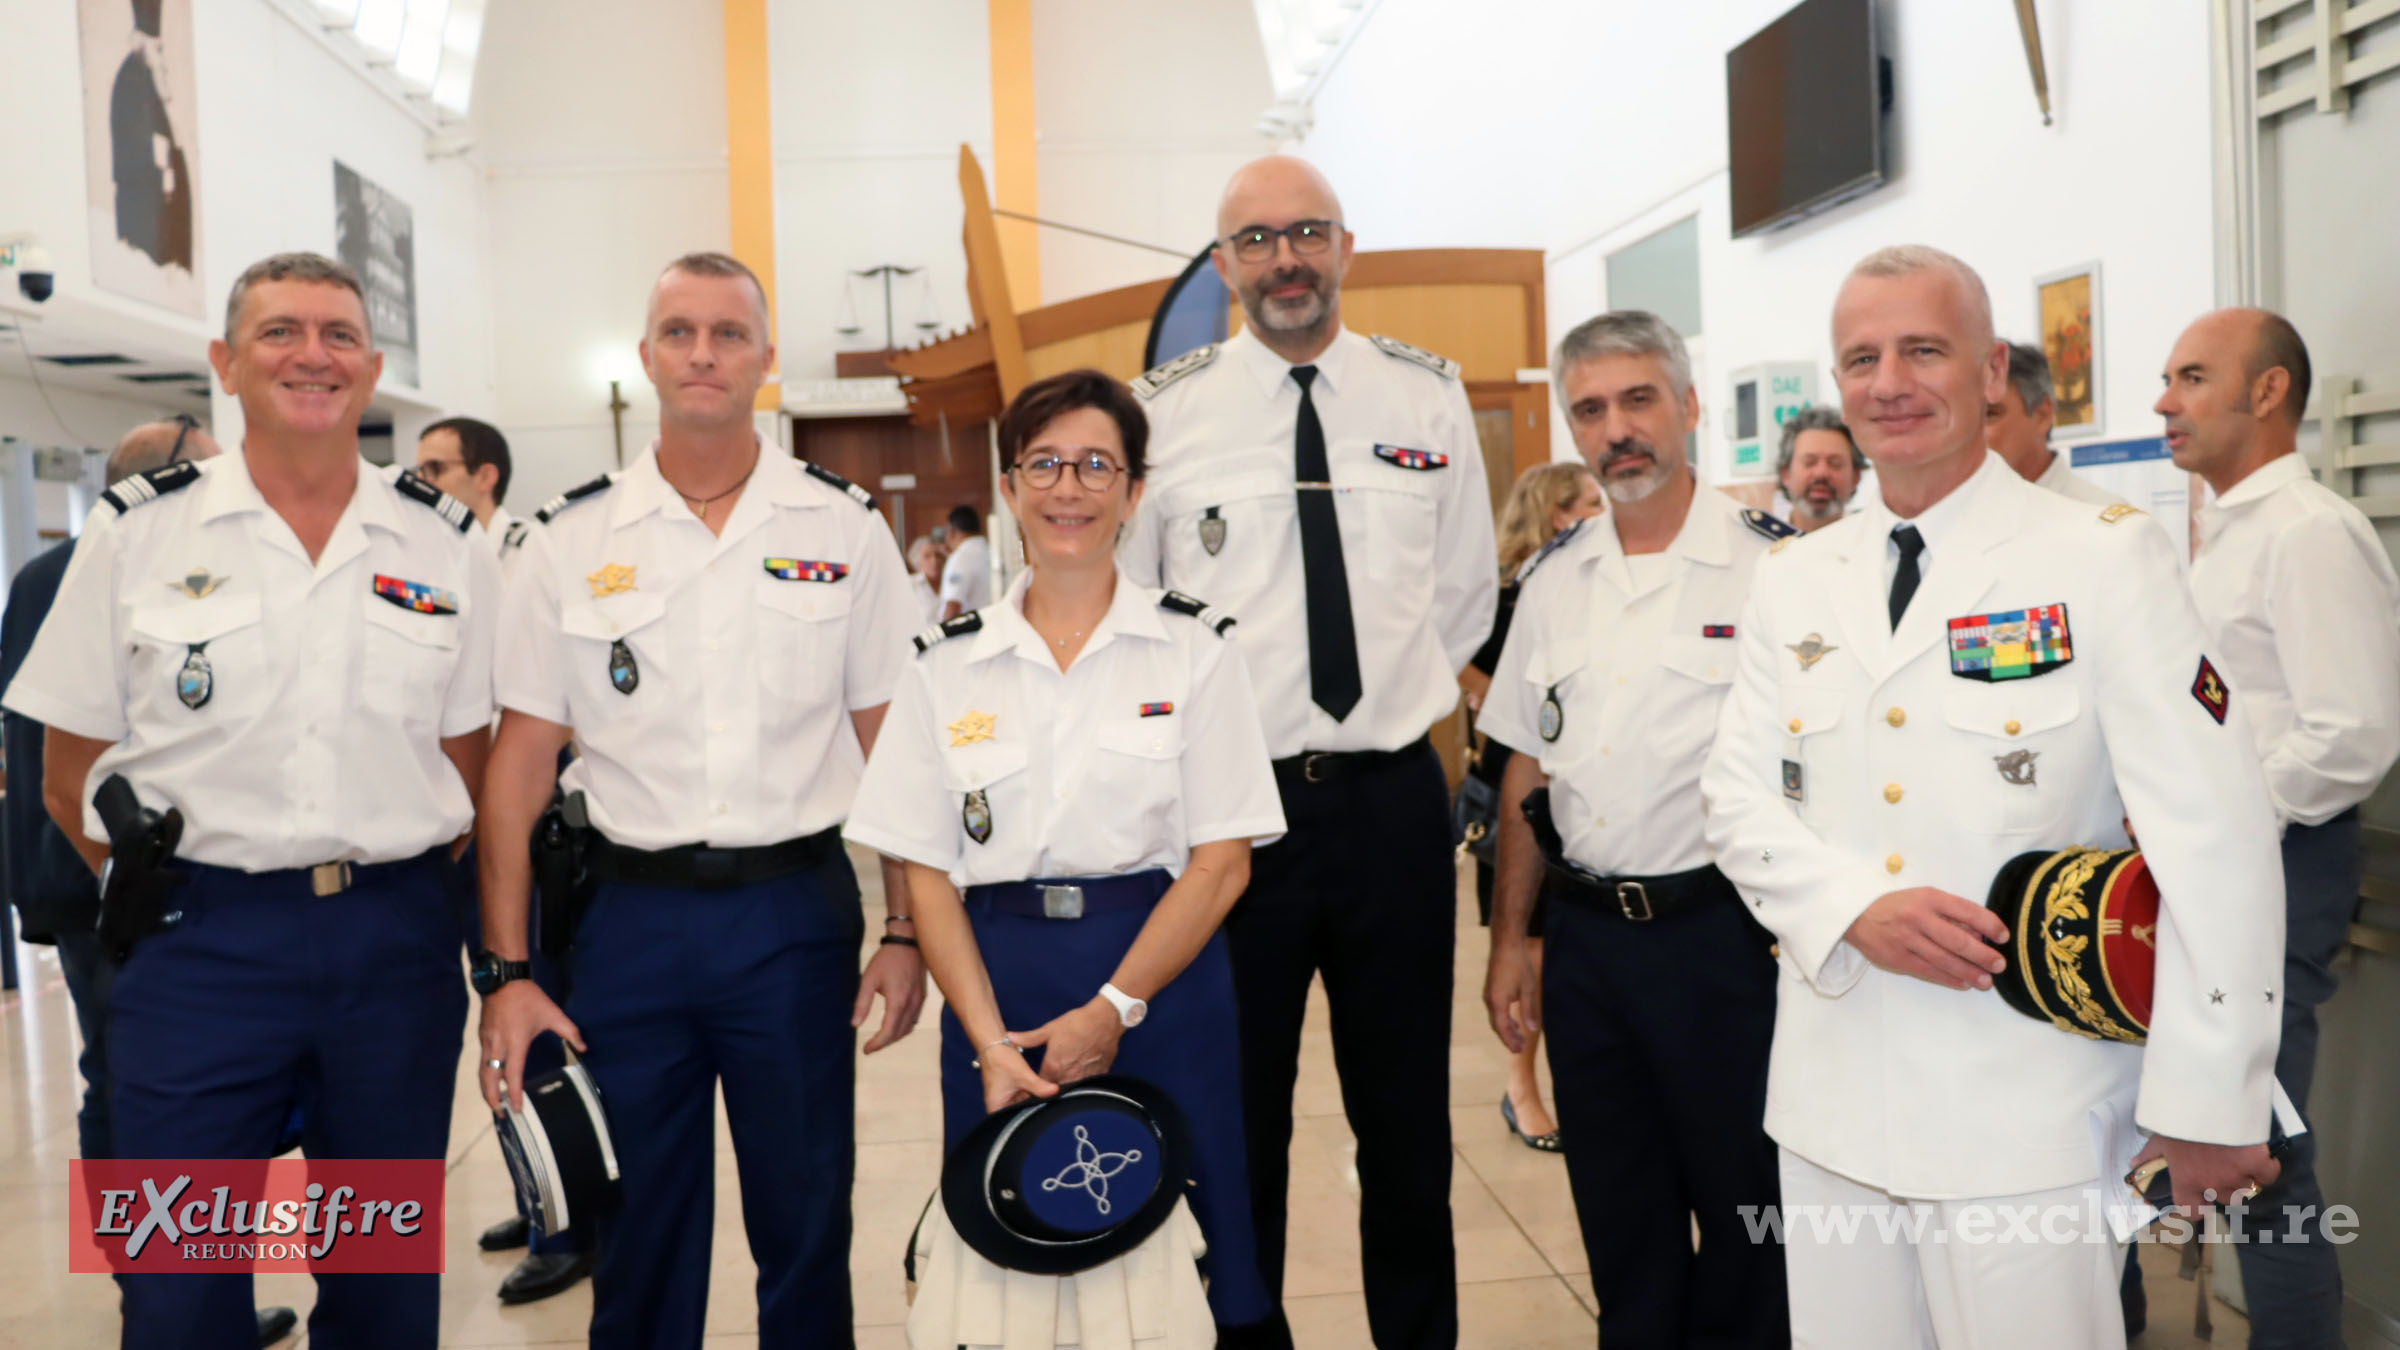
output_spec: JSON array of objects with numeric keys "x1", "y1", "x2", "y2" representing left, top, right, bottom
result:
[{"x1": 1121, "y1": 329, "x2": 1500, "y2": 759}]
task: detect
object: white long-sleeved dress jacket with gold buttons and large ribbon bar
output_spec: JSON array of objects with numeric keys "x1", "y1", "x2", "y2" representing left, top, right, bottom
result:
[{"x1": 1702, "y1": 454, "x2": 2282, "y2": 1201}]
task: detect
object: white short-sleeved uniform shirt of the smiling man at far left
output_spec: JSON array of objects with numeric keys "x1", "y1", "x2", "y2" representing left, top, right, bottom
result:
[{"x1": 7, "y1": 452, "x2": 502, "y2": 872}]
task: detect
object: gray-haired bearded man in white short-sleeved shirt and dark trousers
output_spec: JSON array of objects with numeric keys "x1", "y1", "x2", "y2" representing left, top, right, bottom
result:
[{"x1": 1478, "y1": 310, "x2": 1793, "y2": 1350}]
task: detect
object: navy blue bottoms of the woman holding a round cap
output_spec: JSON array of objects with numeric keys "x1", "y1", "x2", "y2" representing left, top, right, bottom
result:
[{"x1": 941, "y1": 872, "x2": 1274, "y2": 1326}]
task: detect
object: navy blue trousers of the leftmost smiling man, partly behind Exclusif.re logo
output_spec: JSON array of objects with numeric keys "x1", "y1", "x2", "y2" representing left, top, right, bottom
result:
[{"x1": 108, "y1": 855, "x2": 466, "y2": 1350}]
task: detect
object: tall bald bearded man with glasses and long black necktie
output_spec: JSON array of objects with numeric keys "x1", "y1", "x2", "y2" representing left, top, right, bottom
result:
[{"x1": 1123, "y1": 156, "x2": 1498, "y2": 1348}]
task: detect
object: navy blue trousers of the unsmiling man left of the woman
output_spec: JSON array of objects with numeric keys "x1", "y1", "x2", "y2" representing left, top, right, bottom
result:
[{"x1": 566, "y1": 853, "x2": 866, "y2": 1350}]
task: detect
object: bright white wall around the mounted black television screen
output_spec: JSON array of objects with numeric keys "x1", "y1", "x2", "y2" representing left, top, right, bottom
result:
[{"x1": 1303, "y1": 0, "x2": 2213, "y2": 514}]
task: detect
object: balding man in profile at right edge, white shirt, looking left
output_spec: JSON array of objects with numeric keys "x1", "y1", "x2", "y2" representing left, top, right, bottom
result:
[{"x1": 2158, "y1": 310, "x2": 2400, "y2": 1345}]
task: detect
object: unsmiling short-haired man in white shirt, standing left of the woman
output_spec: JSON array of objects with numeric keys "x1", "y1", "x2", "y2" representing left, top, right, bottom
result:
[{"x1": 475, "y1": 252, "x2": 924, "y2": 1350}]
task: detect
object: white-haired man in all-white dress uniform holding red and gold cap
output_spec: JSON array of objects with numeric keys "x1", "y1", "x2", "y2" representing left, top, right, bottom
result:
[{"x1": 1702, "y1": 245, "x2": 2282, "y2": 1348}]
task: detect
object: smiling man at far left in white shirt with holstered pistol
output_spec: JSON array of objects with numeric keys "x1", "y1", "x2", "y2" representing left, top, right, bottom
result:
[{"x1": 7, "y1": 252, "x2": 499, "y2": 1348}]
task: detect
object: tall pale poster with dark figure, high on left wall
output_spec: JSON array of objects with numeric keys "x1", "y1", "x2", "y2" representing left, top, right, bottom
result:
[{"x1": 80, "y1": 0, "x2": 202, "y2": 317}]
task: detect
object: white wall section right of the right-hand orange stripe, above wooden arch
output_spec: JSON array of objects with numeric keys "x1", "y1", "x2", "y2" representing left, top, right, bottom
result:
[{"x1": 1034, "y1": 0, "x2": 1274, "y2": 303}]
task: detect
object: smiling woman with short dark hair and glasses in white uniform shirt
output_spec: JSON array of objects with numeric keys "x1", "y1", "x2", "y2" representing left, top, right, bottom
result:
[{"x1": 847, "y1": 370, "x2": 1284, "y2": 1345}]
